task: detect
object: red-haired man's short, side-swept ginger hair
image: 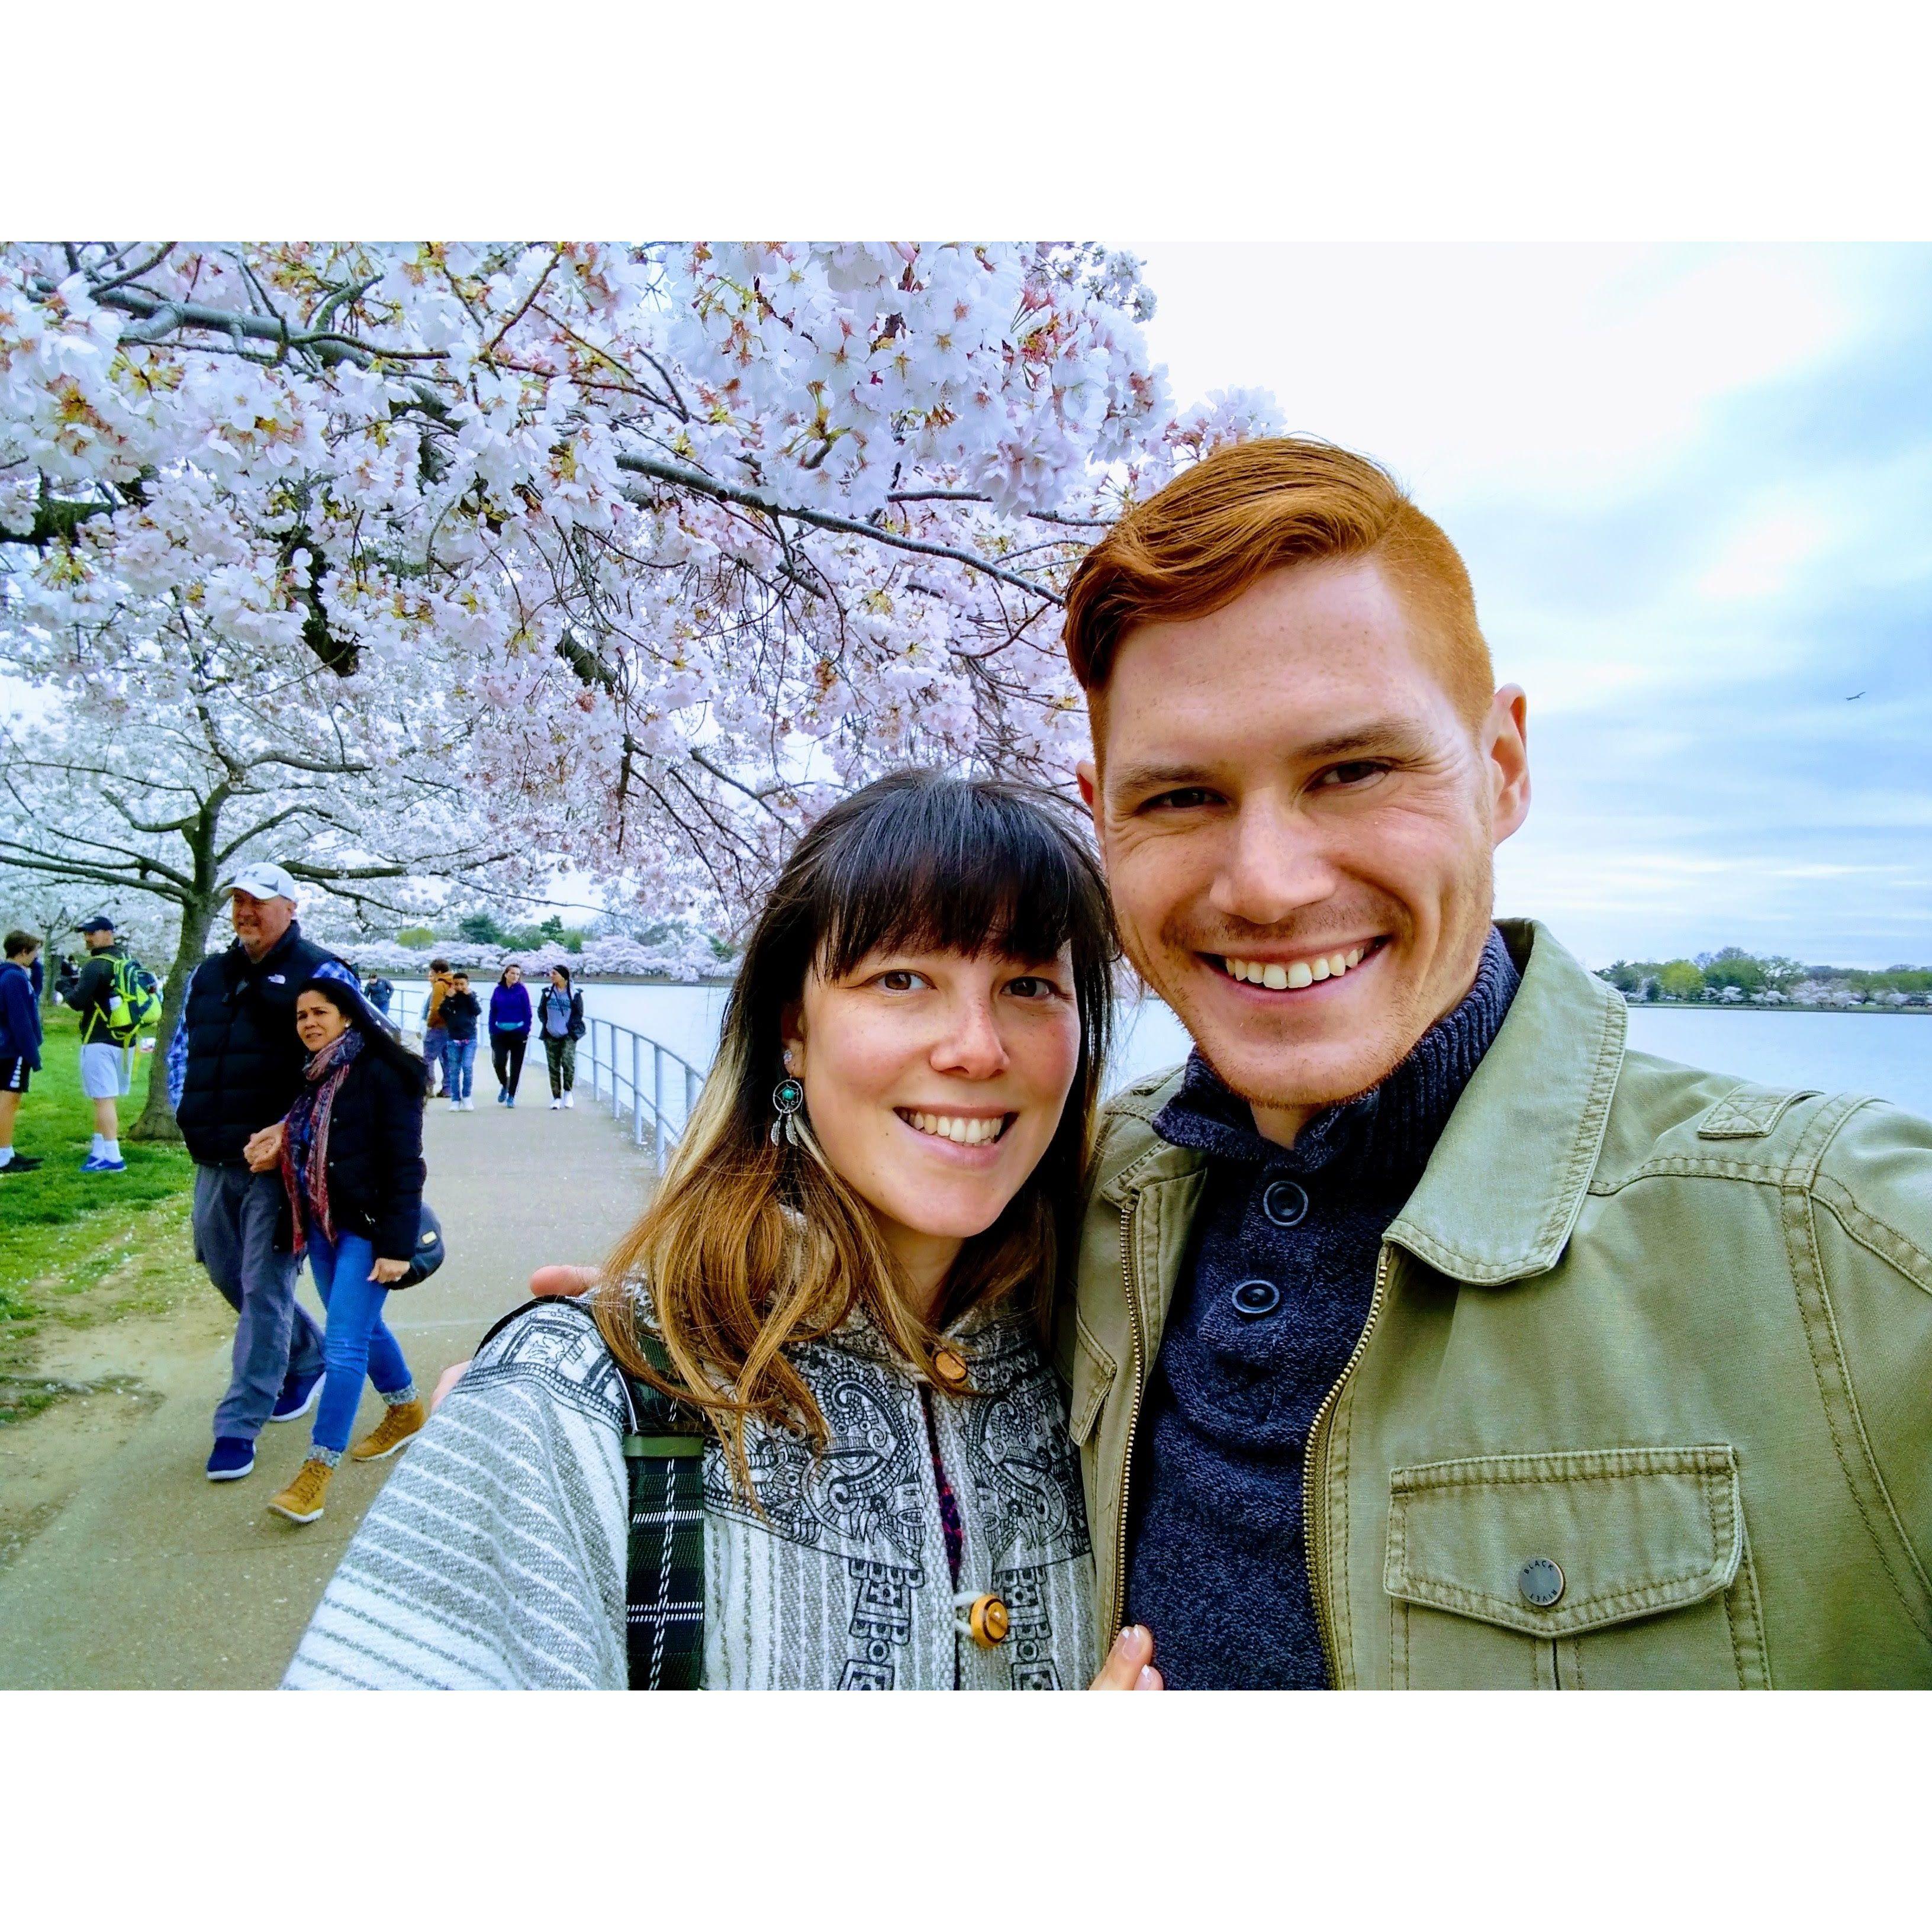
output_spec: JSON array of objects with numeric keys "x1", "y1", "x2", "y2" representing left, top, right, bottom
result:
[{"x1": 1062, "y1": 437, "x2": 1495, "y2": 724}]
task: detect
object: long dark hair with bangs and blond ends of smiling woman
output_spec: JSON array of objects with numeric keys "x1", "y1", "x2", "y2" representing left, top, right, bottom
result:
[{"x1": 593, "y1": 771, "x2": 1119, "y2": 1492}]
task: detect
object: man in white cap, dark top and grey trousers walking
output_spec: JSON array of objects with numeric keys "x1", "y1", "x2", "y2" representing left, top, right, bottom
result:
[{"x1": 168, "y1": 864, "x2": 359, "y2": 1482}]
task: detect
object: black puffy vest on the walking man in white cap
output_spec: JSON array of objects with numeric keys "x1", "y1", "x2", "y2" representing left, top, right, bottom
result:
[{"x1": 174, "y1": 920, "x2": 340, "y2": 1167}]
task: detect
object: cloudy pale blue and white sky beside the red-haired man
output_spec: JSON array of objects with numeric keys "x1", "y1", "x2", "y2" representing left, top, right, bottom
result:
[{"x1": 1130, "y1": 242, "x2": 1932, "y2": 966}]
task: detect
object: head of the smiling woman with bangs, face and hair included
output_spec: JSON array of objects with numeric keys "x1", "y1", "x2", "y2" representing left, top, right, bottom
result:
[{"x1": 599, "y1": 773, "x2": 1113, "y2": 1458}]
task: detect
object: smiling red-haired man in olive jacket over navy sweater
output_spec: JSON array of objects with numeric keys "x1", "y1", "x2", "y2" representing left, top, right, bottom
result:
[{"x1": 1061, "y1": 440, "x2": 1932, "y2": 1686}]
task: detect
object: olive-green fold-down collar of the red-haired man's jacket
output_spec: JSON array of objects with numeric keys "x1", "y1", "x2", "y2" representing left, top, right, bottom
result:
[{"x1": 1099, "y1": 920, "x2": 1627, "y2": 1287}]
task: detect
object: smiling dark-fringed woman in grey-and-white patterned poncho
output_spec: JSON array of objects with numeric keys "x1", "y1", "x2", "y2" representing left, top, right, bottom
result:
[{"x1": 290, "y1": 773, "x2": 1159, "y2": 1690}]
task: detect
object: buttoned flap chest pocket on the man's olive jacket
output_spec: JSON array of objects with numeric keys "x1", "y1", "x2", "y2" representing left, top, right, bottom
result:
[{"x1": 1383, "y1": 1443, "x2": 1770, "y2": 1690}]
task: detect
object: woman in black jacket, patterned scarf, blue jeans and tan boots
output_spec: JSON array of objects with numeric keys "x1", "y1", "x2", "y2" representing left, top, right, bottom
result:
[{"x1": 249, "y1": 978, "x2": 427, "y2": 1522}]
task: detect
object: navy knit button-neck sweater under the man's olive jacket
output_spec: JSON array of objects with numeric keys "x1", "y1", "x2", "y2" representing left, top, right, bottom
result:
[{"x1": 1126, "y1": 931, "x2": 1516, "y2": 1690}]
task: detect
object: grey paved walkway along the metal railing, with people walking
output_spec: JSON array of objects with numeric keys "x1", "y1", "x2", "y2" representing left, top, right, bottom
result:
[{"x1": 0, "y1": 1089, "x2": 649, "y2": 1689}]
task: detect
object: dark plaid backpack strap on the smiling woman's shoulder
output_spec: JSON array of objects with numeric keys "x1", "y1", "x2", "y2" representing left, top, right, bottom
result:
[{"x1": 624, "y1": 1335, "x2": 705, "y2": 1690}]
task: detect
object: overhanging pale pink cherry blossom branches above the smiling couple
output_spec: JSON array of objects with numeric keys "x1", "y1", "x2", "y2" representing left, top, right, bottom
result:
[{"x1": 0, "y1": 242, "x2": 1273, "y2": 920}]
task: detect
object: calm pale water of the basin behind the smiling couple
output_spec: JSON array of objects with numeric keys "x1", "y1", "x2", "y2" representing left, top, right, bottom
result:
[{"x1": 400, "y1": 983, "x2": 1932, "y2": 1117}]
